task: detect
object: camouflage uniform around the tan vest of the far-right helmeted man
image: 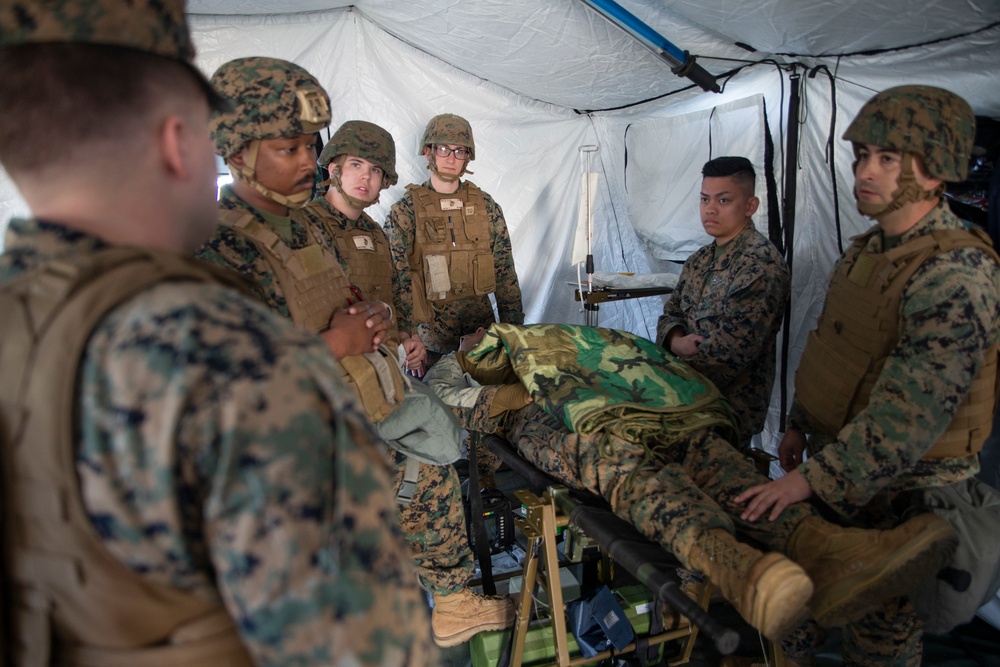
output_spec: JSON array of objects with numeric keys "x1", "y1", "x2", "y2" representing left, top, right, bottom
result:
[{"x1": 789, "y1": 202, "x2": 1000, "y2": 665}]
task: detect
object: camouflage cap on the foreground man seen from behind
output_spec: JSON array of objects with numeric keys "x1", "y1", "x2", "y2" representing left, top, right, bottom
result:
[{"x1": 0, "y1": 0, "x2": 227, "y2": 109}]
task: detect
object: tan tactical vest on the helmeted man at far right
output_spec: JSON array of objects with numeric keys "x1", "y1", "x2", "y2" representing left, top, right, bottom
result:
[{"x1": 795, "y1": 229, "x2": 1000, "y2": 459}]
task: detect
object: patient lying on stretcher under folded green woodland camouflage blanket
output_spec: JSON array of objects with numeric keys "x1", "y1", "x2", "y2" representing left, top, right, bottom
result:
[{"x1": 425, "y1": 324, "x2": 957, "y2": 640}]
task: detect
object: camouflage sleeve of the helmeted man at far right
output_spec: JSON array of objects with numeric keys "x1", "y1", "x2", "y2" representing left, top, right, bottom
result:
[{"x1": 799, "y1": 249, "x2": 1000, "y2": 516}]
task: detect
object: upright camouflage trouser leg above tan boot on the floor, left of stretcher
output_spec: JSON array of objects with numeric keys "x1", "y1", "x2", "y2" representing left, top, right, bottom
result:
[{"x1": 392, "y1": 451, "x2": 475, "y2": 595}]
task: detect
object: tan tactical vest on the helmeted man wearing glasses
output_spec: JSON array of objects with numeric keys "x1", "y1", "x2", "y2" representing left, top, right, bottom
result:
[{"x1": 406, "y1": 181, "x2": 496, "y2": 323}]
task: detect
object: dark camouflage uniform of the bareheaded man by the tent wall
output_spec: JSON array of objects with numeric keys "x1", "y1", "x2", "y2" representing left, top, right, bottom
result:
[{"x1": 656, "y1": 222, "x2": 789, "y2": 443}]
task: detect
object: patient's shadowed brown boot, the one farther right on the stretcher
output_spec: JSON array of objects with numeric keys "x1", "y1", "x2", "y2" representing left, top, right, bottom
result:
[{"x1": 785, "y1": 514, "x2": 958, "y2": 627}]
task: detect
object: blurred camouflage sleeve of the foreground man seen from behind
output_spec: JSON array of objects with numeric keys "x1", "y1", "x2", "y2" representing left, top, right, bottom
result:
[{"x1": 78, "y1": 283, "x2": 434, "y2": 667}]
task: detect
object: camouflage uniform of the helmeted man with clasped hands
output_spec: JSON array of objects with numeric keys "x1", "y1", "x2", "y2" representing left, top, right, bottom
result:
[{"x1": 197, "y1": 186, "x2": 474, "y2": 594}]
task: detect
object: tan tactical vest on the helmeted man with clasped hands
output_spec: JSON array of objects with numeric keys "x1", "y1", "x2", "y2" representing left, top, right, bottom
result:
[{"x1": 219, "y1": 210, "x2": 405, "y2": 422}]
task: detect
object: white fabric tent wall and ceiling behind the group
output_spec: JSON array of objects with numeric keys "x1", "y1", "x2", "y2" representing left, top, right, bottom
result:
[{"x1": 0, "y1": 0, "x2": 1000, "y2": 462}]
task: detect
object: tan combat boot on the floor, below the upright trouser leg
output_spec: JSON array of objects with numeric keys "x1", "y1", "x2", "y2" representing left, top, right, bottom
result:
[{"x1": 431, "y1": 588, "x2": 514, "y2": 648}]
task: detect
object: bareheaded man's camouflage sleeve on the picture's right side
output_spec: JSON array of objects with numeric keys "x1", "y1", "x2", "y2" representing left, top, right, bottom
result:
[{"x1": 668, "y1": 252, "x2": 789, "y2": 387}]
